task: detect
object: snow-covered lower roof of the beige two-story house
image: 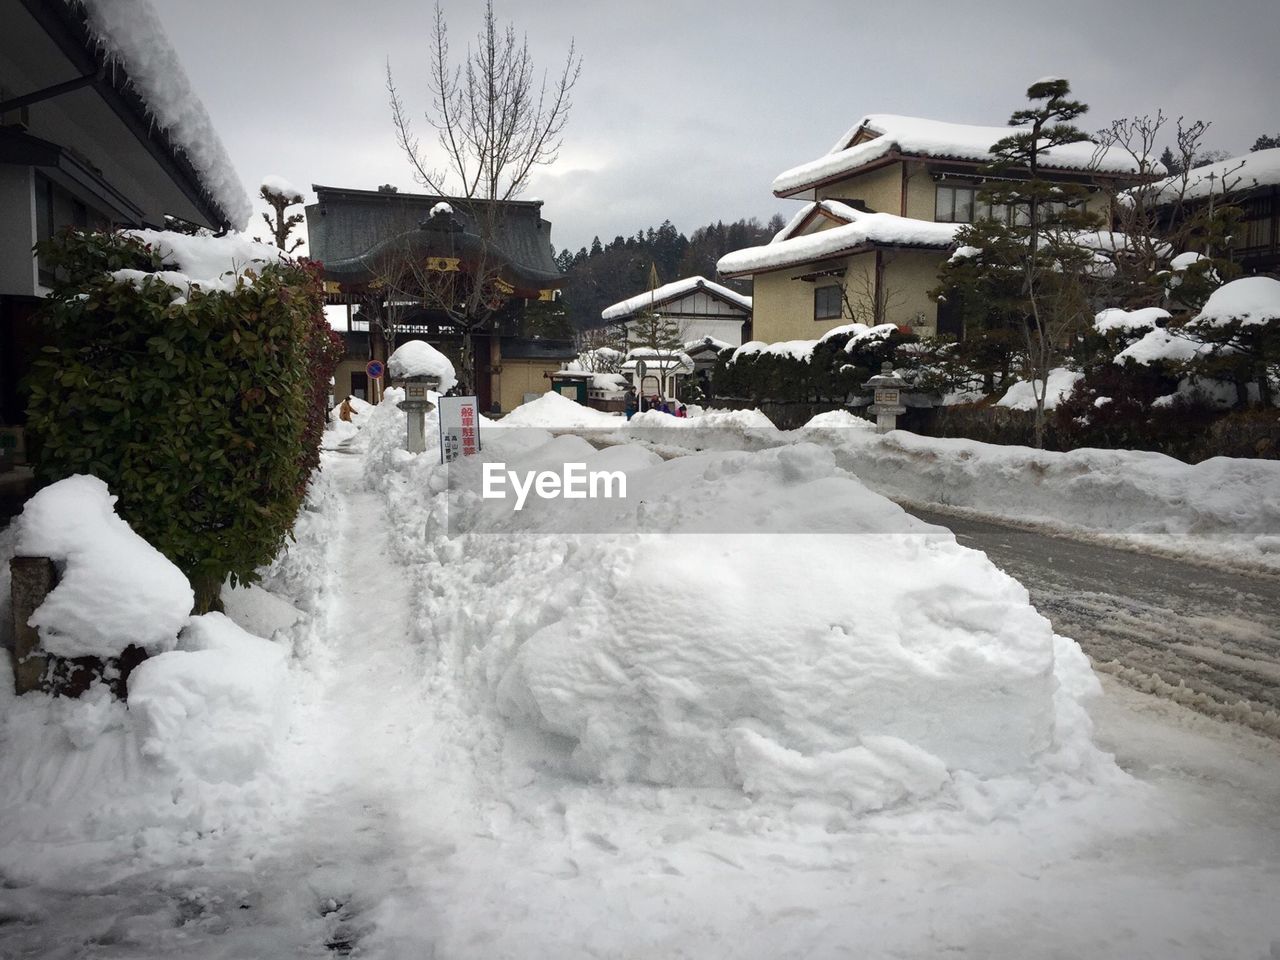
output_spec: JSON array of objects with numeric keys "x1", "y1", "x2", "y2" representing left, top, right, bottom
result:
[{"x1": 716, "y1": 200, "x2": 965, "y2": 276}]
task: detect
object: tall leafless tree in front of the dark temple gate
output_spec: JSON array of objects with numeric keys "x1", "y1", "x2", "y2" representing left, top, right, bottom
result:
[{"x1": 385, "y1": 0, "x2": 581, "y2": 392}]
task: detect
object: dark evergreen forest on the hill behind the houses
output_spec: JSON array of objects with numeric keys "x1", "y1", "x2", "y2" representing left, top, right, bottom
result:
[{"x1": 556, "y1": 214, "x2": 786, "y2": 330}]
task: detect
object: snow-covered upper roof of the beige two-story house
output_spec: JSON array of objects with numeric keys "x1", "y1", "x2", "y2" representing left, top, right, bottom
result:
[{"x1": 773, "y1": 114, "x2": 1164, "y2": 197}]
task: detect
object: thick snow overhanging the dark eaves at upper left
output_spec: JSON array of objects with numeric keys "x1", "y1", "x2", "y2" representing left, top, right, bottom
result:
[{"x1": 77, "y1": 0, "x2": 253, "y2": 229}]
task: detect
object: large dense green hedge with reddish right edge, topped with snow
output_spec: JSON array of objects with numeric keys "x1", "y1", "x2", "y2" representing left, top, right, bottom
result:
[{"x1": 28, "y1": 230, "x2": 335, "y2": 611}]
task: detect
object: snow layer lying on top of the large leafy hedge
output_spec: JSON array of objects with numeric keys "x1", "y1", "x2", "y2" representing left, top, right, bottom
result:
[{"x1": 111, "y1": 230, "x2": 289, "y2": 298}]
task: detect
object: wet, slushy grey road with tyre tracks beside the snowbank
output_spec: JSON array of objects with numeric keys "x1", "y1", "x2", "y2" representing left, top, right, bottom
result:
[{"x1": 911, "y1": 507, "x2": 1280, "y2": 737}]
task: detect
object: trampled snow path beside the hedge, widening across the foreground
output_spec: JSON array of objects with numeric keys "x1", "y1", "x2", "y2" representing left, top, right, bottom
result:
[{"x1": 0, "y1": 427, "x2": 1280, "y2": 960}]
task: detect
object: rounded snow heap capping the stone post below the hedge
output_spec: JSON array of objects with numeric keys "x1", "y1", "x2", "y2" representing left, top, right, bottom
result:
[{"x1": 17, "y1": 475, "x2": 195, "y2": 658}]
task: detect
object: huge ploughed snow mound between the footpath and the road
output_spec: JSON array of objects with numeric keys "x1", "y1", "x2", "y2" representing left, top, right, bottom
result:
[{"x1": 353, "y1": 399, "x2": 1103, "y2": 812}]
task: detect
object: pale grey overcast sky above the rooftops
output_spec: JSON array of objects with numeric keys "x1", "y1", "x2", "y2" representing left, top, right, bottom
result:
[{"x1": 154, "y1": 0, "x2": 1280, "y2": 257}]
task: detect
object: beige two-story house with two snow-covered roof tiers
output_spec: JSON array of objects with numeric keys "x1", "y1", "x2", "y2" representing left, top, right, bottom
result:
[{"x1": 717, "y1": 114, "x2": 1139, "y2": 343}]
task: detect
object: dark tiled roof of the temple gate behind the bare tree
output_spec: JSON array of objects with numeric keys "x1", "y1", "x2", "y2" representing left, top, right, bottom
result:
[{"x1": 306, "y1": 184, "x2": 564, "y2": 291}]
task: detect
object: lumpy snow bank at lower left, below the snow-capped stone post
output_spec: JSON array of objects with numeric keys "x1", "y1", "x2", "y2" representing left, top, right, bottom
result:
[{"x1": 0, "y1": 613, "x2": 294, "y2": 884}]
